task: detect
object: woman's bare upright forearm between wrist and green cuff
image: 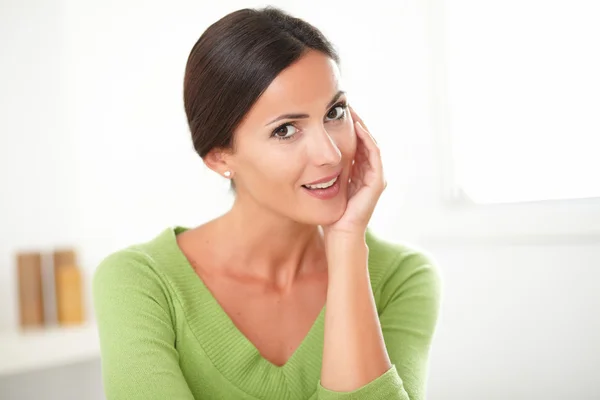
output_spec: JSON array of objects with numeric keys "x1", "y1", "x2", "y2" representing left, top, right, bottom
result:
[{"x1": 321, "y1": 236, "x2": 391, "y2": 392}]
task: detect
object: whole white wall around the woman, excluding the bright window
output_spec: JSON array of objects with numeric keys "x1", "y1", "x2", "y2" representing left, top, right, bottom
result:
[{"x1": 0, "y1": 0, "x2": 600, "y2": 400}]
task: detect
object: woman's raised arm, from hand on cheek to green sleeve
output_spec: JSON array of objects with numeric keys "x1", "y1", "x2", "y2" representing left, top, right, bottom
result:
[{"x1": 317, "y1": 108, "x2": 438, "y2": 400}]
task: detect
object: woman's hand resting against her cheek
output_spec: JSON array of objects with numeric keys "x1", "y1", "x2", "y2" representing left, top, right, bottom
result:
[{"x1": 323, "y1": 107, "x2": 387, "y2": 236}]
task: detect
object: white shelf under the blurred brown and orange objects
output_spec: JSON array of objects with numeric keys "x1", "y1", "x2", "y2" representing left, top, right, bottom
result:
[{"x1": 0, "y1": 323, "x2": 100, "y2": 377}]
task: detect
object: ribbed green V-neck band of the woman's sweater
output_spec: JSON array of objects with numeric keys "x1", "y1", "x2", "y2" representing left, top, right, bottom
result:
[{"x1": 163, "y1": 226, "x2": 326, "y2": 399}]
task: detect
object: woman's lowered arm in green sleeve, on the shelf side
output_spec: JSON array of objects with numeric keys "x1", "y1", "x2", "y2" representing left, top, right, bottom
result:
[{"x1": 93, "y1": 250, "x2": 194, "y2": 400}]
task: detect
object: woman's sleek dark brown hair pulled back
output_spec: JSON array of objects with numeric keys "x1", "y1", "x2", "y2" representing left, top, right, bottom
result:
[{"x1": 183, "y1": 6, "x2": 340, "y2": 190}]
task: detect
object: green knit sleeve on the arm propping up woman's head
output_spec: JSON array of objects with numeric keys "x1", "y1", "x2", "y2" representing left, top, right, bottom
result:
[{"x1": 317, "y1": 252, "x2": 441, "y2": 400}]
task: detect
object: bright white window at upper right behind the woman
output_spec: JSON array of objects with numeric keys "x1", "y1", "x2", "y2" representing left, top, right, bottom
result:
[{"x1": 440, "y1": 0, "x2": 600, "y2": 204}]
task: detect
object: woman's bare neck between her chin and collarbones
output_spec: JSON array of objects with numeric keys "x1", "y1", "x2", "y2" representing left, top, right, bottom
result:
[{"x1": 215, "y1": 195, "x2": 325, "y2": 289}]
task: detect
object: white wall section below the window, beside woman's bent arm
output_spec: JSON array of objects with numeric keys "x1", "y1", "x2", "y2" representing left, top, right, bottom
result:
[{"x1": 424, "y1": 242, "x2": 600, "y2": 400}]
